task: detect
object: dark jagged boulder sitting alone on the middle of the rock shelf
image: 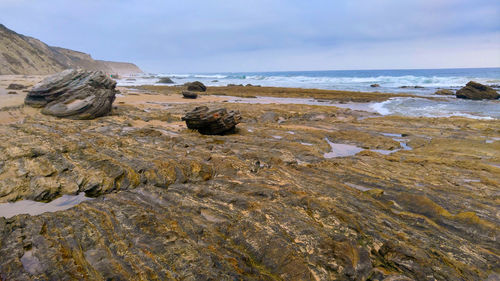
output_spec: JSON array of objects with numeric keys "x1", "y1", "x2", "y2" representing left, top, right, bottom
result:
[{"x1": 182, "y1": 106, "x2": 241, "y2": 135}]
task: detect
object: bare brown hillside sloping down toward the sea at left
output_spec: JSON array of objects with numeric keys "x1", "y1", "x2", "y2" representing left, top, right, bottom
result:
[{"x1": 0, "y1": 24, "x2": 142, "y2": 75}]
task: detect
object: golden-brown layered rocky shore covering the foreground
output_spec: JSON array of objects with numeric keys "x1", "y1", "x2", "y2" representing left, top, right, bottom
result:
[{"x1": 0, "y1": 77, "x2": 500, "y2": 280}]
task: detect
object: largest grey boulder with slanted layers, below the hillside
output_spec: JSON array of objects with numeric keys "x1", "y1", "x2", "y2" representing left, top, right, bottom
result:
[{"x1": 24, "y1": 69, "x2": 118, "y2": 119}]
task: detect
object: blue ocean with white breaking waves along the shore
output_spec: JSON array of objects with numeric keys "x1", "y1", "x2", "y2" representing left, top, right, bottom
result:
[{"x1": 118, "y1": 68, "x2": 500, "y2": 119}]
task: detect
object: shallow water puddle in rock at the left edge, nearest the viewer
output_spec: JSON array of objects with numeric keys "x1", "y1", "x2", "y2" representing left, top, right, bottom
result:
[{"x1": 0, "y1": 192, "x2": 92, "y2": 218}]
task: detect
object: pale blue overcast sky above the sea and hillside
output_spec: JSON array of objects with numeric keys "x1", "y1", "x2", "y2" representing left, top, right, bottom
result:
[{"x1": 0, "y1": 0, "x2": 500, "y2": 73}]
